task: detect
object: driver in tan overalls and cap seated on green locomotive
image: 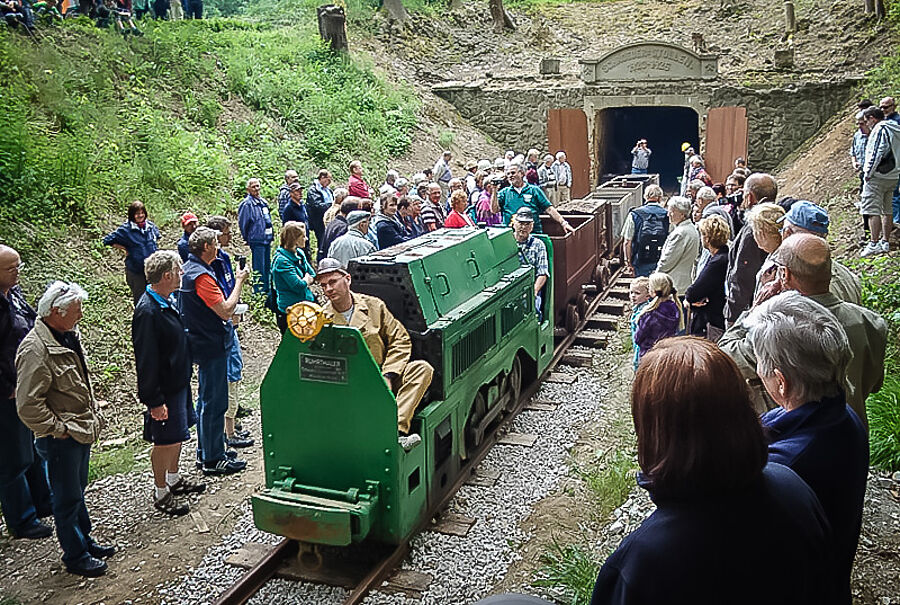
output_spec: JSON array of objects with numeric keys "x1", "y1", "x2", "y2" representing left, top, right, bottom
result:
[{"x1": 316, "y1": 258, "x2": 434, "y2": 451}]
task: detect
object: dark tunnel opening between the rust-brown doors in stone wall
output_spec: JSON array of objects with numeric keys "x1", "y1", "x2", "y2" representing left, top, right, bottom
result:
[{"x1": 595, "y1": 107, "x2": 700, "y2": 192}]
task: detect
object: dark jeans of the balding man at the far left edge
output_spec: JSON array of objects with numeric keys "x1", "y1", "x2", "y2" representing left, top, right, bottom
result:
[{"x1": 0, "y1": 399, "x2": 51, "y2": 534}]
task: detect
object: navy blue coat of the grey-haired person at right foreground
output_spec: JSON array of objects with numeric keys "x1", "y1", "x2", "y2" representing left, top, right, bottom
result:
[{"x1": 762, "y1": 396, "x2": 869, "y2": 603}]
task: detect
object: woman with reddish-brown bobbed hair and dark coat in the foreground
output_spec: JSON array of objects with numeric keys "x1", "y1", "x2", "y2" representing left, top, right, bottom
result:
[{"x1": 591, "y1": 336, "x2": 836, "y2": 605}]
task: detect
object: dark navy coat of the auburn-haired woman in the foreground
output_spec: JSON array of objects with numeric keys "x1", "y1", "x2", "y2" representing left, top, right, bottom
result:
[{"x1": 591, "y1": 463, "x2": 835, "y2": 605}]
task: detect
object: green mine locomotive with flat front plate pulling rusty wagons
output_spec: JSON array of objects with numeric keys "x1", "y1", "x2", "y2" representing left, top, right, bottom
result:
[{"x1": 253, "y1": 228, "x2": 554, "y2": 545}]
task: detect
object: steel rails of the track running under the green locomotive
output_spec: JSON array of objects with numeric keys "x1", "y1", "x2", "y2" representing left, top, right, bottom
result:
[{"x1": 215, "y1": 268, "x2": 623, "y2": 605}]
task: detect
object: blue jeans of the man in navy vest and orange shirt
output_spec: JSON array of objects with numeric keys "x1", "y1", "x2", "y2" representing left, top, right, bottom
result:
[{"x1": 197, "y1": 356, "x2": 228, "y2": 464}]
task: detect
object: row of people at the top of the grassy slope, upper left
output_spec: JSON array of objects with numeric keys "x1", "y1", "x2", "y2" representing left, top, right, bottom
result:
[{"x1": 0, "y1": 0, "x2": 203, "y2": 37}]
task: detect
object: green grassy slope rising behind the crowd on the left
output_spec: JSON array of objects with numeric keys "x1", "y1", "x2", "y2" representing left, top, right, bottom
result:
[{"x1": 0, "y1": 14, "x2": 417, "y2": 446}]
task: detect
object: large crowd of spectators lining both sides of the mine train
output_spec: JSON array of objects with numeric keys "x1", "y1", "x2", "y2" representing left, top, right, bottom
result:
[{"x1": 0, "y1": 119, "x2": 900, "y2": 603}]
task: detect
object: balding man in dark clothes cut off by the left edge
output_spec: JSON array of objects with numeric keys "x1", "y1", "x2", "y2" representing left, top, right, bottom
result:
[{"x1": 0, "y1": 245, "x2": 53, "y2": 539}]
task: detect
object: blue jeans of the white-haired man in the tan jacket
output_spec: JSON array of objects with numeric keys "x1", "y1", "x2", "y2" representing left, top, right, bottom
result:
[{"x1": 34, "y1": 437, "x2": 91, "y2": 563}]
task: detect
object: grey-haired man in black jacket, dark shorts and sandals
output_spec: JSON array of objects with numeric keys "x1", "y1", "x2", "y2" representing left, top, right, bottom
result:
[{"x1": 131, "y1": 250, "x2": 206, "y2": 515}]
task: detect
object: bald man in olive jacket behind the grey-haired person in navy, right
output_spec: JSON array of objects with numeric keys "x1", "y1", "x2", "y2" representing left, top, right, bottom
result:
[{"x1": 719, "y1": 233, "x2": 887, "y2": 422}]
